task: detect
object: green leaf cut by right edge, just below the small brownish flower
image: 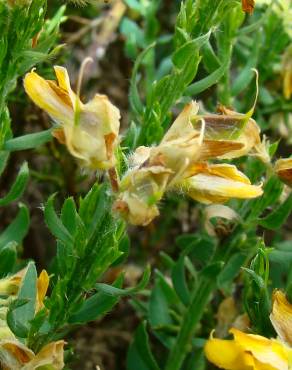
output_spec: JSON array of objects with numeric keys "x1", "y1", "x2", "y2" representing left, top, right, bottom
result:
[{"x1": 259, "y1": 195, "x2": 292, "y2": 230}]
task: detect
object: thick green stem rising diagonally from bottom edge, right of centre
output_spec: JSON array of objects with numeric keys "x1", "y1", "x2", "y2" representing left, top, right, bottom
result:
[{"x1": 165, "y1": 278, "x2": 216, "y2": 370}]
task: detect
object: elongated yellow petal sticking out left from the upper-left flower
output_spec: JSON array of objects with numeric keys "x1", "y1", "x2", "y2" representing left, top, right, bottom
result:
[{"x1": 24, "y1": 71, "x2": 74, "y2": 123}]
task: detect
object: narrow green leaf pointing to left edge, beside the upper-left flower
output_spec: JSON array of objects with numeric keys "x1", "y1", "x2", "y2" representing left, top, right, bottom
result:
[{"x1": 3, "y1": 128, "x2": 53, "y2": 152}]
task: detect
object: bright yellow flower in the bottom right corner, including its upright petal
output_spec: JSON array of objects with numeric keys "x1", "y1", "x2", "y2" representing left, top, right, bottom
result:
[{"x1": 205, "y1": 291, "x2": 292, "y2": 370}]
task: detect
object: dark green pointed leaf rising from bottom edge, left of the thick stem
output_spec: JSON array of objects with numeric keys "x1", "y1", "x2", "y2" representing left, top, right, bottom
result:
[{"x1": 127, "y1": 322, "x2": 159, "y2": 370}]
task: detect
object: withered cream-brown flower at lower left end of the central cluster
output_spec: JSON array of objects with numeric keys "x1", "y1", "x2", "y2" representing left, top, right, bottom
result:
[{"x1": 114, "y1": 166, "x2": 171, "y2": 226}]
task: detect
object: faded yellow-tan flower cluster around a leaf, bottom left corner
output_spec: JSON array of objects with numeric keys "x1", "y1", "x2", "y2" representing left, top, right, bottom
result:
[{"x1": 0, "y1": 268, "x2": 65, "y2": 370}]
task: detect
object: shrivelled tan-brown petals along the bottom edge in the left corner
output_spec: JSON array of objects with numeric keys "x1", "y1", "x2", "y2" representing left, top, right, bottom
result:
[{"x1": 0, "y1": 339, "x2": 65, "y2": 370}]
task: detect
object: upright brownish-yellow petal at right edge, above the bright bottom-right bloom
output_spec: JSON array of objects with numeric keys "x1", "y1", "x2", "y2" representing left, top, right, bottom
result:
[{"x1": 270, "y1": 290, "x2": 292, "y2": 346}]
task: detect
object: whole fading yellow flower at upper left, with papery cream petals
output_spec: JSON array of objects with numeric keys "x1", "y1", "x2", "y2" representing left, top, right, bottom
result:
[{"x1": 24, "y1": 66, "x2": 120, "y2": 169}]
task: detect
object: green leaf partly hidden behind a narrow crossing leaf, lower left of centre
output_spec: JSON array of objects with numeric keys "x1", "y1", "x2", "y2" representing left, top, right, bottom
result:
[{"x1": 68, "y1": 275, "x2": 124, "y2": 324}]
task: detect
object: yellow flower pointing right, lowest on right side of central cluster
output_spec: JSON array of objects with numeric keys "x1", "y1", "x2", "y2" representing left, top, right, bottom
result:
[{"x1": 174, "y1": 163, "x2": 263, "y2": 204}]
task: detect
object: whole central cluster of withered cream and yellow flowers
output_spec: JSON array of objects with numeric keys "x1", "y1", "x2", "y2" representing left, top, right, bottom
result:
[{"x1": 114, "y1": 102, "x2": 269, "y2": 225}]
